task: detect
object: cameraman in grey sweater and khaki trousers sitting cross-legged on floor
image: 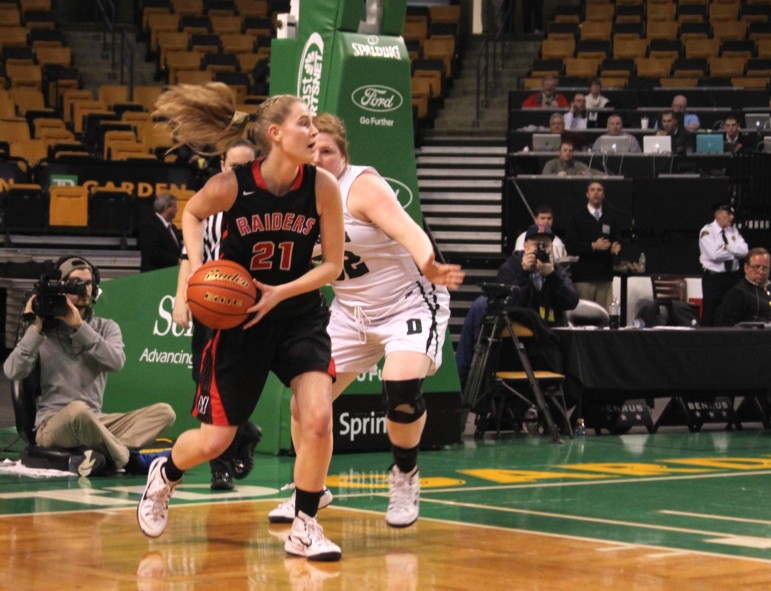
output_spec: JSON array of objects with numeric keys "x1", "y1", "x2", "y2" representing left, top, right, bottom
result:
[{"x1": 3, "y1": 257, "x2": 176, "y2": 476}]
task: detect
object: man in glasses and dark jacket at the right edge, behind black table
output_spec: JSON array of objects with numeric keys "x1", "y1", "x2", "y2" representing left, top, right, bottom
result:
[{"x1": 718, "y1": 248, "x2": 771, "y2": 326}]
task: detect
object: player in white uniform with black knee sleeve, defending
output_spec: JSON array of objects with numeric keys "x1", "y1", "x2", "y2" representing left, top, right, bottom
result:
[{"x1": 269, "y1": 114, "x2": 464, "y2": 527}]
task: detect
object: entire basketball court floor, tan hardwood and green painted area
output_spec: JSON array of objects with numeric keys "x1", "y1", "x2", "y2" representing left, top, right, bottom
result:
[{"x1": 0, "y1": 429, "x2": 771, "y2": 591}]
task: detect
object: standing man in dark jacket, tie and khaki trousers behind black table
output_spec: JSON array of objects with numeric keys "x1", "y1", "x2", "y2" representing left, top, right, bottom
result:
[{"x1": 565, "y1": 181, "x2": 621, "y2": 311}]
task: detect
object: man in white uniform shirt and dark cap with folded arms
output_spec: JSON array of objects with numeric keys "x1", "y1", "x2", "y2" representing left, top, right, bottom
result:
[{"x1": 699, "y1": 200, "x2": 749, "y2": 326}]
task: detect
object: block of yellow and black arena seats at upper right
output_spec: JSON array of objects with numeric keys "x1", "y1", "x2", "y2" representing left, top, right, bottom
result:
[{"x1": 522, "y1": 0, "x2": 771, "y2": 88}]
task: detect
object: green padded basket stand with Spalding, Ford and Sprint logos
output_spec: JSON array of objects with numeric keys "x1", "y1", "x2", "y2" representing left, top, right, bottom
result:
[{"x1": 270, "y1": 0, "x2": 460, "y2": 450}]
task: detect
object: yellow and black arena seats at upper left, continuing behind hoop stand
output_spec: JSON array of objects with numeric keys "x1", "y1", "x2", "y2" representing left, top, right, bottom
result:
[{"x1": 0, "y1": 0, "x2": 462, "y2": 248}]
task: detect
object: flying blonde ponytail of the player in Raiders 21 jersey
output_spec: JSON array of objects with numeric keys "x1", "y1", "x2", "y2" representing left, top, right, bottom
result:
[{"x1": 153, "y1": 82, "x2": 301, "y2": 156}]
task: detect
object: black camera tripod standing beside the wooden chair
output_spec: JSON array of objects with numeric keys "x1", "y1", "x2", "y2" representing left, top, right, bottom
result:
[{"x1": 461, "y1": 292, "x2": 572, "y2": 443}]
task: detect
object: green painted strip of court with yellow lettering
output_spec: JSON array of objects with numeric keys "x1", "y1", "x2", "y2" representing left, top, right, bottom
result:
[{"x1": 0, "y1": 430, "x2": 771, "y2": 560}]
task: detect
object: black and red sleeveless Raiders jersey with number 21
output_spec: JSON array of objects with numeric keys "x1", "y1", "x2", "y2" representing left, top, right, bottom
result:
[{"x1": 221, "y1": 158, "x2": 322, "y2": 316}]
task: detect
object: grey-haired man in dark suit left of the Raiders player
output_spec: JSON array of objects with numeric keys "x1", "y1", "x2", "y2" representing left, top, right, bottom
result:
[{"x1": 139, "y1": 193, "x2": 182, "y2": 272}]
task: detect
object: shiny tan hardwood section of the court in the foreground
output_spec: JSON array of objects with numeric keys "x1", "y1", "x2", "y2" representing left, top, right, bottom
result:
[{"x1": 0, "y1": 502, "x2": 771, "y2": 591}]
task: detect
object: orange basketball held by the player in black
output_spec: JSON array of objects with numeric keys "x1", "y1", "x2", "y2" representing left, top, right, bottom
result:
[{"x1": 187, "y1": 261, "x2": 257, "y2": 329}]
